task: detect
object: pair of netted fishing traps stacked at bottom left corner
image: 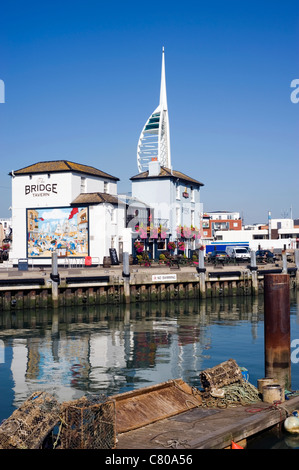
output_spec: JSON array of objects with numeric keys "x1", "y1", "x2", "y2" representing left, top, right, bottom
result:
[{"x1": 0, "y1": 392, "x2": 116, "y2": 449}]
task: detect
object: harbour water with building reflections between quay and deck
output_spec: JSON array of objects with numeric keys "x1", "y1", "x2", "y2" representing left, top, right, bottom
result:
[{"x1": 0, "y1": 291, "x2": 299, "y2": 447}]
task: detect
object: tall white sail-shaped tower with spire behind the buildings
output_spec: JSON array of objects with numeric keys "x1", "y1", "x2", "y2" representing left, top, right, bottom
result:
[{"x1": 137, "y1": 47, "x2": 171, "y2": 173}]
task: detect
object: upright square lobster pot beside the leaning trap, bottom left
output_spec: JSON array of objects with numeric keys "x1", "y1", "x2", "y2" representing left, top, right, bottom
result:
[{"x1": 60, "y1": 397, "x2": 116, "y2": 449}]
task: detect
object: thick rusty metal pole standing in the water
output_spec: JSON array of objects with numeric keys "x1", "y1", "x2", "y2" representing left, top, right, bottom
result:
[{"x1": 264, "y1": 274, "x2": 291, "y2": 390}]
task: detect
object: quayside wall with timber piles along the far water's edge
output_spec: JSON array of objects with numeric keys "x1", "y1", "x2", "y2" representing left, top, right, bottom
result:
[{"x1": 0, "y1": 267, "x2": 298, "y2": 311}]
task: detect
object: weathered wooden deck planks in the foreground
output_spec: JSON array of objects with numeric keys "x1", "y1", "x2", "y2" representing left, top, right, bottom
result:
[{"x1": 116, "y1": 397, "x2": 299, "y2": 449}]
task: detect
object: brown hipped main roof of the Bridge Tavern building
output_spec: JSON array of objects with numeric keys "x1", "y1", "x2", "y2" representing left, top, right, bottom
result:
[{"x1": 9, "y1": 160, "x2": 119, "y2": 181}]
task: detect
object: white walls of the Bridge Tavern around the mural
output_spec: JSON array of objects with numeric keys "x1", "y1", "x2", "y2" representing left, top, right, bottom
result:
[{"x1": 10, "y1": 172, "x2": 125, "y2": 264}]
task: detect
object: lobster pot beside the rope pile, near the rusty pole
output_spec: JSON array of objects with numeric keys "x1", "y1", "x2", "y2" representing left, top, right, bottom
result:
[{"x1": 200, "y1": 359, "x2": 243, "y2": 390}]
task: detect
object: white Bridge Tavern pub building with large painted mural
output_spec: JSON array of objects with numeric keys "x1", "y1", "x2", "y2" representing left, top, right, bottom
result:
[{"x1": 10, "y1": 160, "x2": 131, "y2": 265}]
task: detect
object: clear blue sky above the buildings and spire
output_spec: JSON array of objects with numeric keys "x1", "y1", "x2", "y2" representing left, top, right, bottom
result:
[{"x1": 0, "y1": 0, "x2": 299, "y2": 223}]
